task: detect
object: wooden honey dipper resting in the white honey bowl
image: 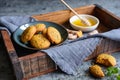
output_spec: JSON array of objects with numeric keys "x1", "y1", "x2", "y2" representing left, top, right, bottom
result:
[{"x1": 61, "y1": 0, "x2": 91, "y2": 26}]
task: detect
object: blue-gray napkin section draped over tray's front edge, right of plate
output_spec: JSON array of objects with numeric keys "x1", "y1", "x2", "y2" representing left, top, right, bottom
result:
[{"x1": 43, "y1": 29, "x2": 120, "y2": 75}]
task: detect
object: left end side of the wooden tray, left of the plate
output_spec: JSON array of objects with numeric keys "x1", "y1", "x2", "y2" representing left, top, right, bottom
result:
[{"x1": 1, "y1": 30, "x2": 23, "y2": 80}]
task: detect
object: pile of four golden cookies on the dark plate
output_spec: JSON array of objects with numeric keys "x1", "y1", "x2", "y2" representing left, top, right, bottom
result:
[{"x1": 21, "y1": 23, "x2": 62, "y2": 49}]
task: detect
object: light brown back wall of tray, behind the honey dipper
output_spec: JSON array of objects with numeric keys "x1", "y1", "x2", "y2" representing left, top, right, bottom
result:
[{"x1": 32, "y1": 5, "x2": 95, "y2": 24}]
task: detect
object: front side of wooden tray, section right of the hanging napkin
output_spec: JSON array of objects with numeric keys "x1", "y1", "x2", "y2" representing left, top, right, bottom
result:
[{"x1": 85, "y1": 38, "x2": 120, "y2": 61}]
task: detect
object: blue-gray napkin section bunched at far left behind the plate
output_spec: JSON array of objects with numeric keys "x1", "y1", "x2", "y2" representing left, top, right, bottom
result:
[{"x1": 0, "y1": 16, "x2": 35, "y2": 35}]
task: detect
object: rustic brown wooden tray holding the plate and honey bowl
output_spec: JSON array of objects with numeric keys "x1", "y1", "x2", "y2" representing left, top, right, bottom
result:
[{"x1": 0, "y1": 5, "x2": 120, "y2": 80}]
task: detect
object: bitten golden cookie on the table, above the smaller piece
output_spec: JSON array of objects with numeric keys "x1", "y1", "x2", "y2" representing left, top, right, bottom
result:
[{"x1": 96, "y1": 53, "x2": 116, "y2": 66}]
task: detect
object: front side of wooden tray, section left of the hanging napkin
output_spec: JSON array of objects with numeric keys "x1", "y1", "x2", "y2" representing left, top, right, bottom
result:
[{"x1": 19, "y1": 52, "x2": 57, "y2": 79}]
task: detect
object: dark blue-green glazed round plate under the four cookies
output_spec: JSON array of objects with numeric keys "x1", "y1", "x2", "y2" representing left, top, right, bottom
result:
[{"x1": 13, "y1": 21, "x2": 68, "y2": 50}]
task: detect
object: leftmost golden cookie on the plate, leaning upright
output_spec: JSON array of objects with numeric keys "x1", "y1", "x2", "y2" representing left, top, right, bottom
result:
[{"x1": 21, "y1": 26, "x2": 36, "y2": 43}]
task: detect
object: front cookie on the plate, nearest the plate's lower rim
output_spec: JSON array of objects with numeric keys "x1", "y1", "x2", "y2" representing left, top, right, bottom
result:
[{"x1": 30, "y1": 34, "x2": 50, "y2": 49}]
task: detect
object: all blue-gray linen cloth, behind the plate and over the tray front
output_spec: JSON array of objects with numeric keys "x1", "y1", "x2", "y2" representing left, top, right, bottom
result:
[{"x1": 0, "y1": 16, "x2": 120, "y2": 75}]
